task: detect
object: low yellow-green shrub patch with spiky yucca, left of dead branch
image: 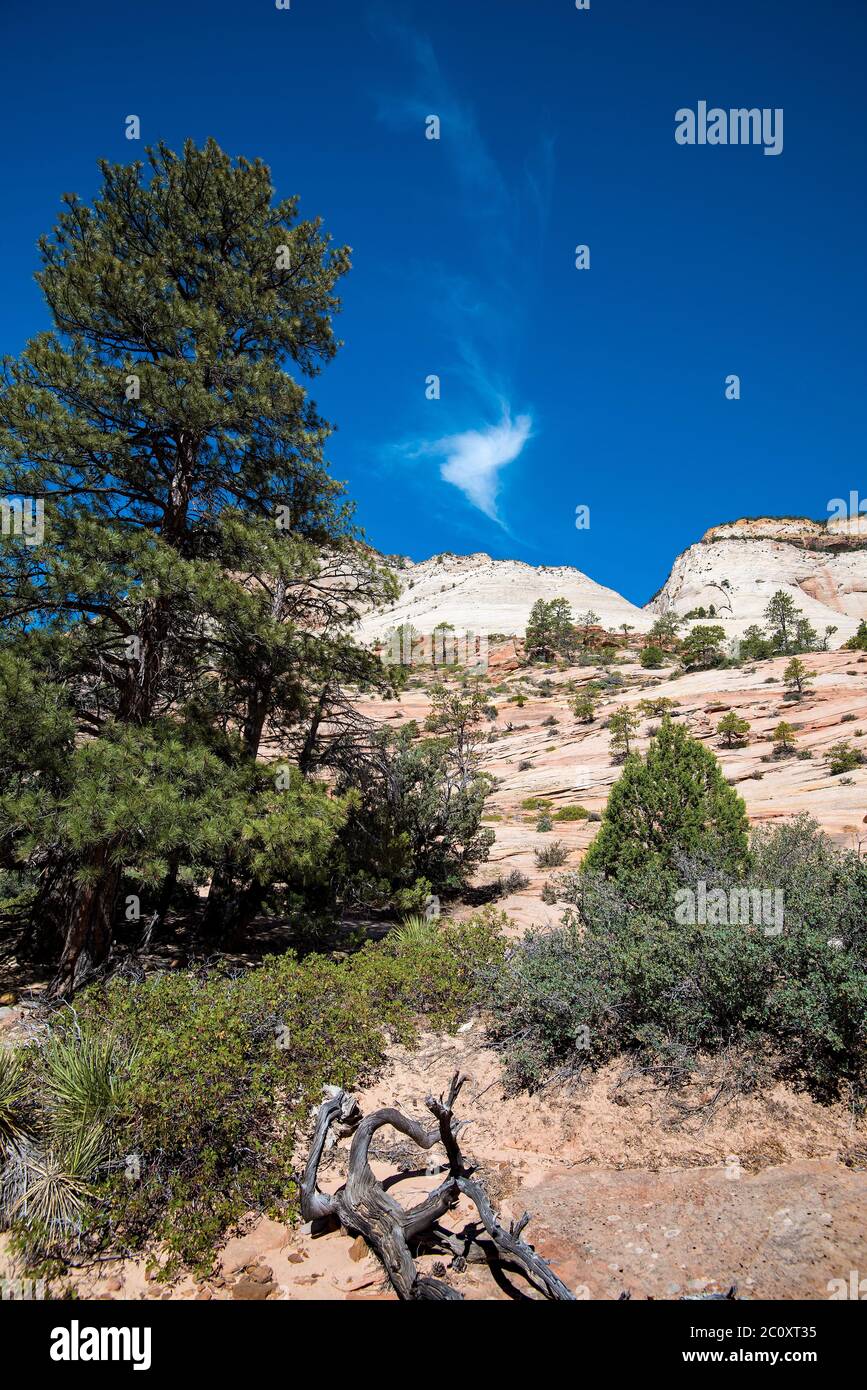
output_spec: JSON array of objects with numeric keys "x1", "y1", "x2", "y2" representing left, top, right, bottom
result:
[{"x1": 0, "y1": 910, "x2": 503, "y2": 1269}]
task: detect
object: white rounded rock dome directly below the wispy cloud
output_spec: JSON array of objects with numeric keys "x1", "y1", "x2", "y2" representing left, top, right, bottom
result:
[{"x1": 358, "y1": 553, "x2": 654, "y2": 641}]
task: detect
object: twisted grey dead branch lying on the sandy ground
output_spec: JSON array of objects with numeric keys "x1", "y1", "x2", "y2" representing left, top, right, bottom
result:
[{"x1": 302, "y1": 1072, "x2": 575, "y2": 1302}]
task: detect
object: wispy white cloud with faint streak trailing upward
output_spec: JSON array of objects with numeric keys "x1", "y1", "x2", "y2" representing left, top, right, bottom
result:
[{"x1": 374, "y1": 16, "x2": 544, "y2": 531}]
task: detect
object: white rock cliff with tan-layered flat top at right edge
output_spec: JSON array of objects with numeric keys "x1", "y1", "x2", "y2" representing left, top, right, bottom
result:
[{"x1": 647, "y1": 517, "x2": 867, "y2": 648}]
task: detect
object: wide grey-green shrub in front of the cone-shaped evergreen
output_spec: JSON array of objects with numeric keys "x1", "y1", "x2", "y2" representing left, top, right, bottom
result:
[{"x1": 489, "y1": 817, "x2": 867, "y2": 1099}]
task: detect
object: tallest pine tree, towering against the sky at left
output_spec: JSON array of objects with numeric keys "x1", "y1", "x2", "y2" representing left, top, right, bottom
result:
[{"x1": 0, "y1": 140, "x2": 389, "y2": 992}]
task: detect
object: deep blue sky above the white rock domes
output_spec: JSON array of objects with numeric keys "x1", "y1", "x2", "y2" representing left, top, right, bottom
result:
[{"x1": 0, "y1": 0, "x2": 867, "y2": 603}]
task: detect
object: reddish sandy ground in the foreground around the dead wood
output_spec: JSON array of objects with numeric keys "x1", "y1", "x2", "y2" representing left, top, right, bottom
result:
[{"x1": 0, "y1": 1020, "x2": 867, "y2": 1301}]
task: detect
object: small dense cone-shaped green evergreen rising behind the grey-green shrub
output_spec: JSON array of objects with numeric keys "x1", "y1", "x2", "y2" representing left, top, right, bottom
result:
[{"x1": 584, "y1": 717, "x2": 748, "y2": 877}]
